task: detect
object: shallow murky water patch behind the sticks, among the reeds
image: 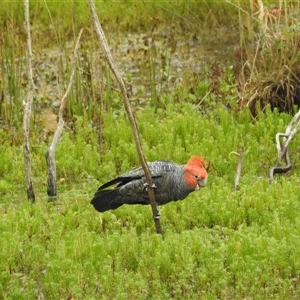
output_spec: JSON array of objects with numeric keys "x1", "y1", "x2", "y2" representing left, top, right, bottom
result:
[{"x1": 3, "y1": 23, "x2": 239, "y2": 123}]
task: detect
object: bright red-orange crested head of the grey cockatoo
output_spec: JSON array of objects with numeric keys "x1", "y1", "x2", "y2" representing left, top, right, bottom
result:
[{"x1": 184, "y1": 156, "x2": 209, "y2": 190}]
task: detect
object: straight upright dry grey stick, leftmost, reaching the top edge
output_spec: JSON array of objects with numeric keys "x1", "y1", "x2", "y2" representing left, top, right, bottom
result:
[{"x1": 23, "y1": 0, "x2": 35, "y2": 203}]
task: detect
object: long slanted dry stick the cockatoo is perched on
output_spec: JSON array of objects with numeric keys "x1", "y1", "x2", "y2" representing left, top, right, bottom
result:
[{"x1": 88, "y1": 0, "x2": 162, "y2": 234}]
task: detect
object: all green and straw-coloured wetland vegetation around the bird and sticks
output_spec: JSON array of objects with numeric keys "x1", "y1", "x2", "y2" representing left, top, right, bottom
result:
[{"x1": 0, "y1": 0, "x2": 300, "y2": 299}]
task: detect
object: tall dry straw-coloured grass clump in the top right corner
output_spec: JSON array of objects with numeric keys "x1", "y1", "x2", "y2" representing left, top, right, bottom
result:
[{"x1": 237, "y1": 1, "x2": 300, "y2": 117}]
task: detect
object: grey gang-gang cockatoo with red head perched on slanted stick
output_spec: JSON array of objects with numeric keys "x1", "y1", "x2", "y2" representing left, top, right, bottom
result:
[{"x1": 91, "y1": 156, "x2": 208, "y2": 212}]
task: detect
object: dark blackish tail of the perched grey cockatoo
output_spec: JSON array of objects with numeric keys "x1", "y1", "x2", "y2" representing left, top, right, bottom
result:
[{"x1": 91, "y1": 189, "x2": 123, "y2": 212}]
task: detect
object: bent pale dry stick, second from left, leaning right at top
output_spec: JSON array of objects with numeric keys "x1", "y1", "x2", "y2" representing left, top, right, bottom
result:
[{"x1": 45, "y1": 29, "x2": 83, "y2": 199}]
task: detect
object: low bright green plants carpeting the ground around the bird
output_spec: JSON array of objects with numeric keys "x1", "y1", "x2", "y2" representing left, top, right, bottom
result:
[{"x1": 0, "y1": 96, "x2": 300, "y2": 299}]
